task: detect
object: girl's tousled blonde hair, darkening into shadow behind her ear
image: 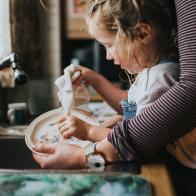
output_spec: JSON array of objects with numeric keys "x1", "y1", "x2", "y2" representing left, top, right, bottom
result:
[{"x1": 86, "y1": 0, "x2": 176, "y2": 64}]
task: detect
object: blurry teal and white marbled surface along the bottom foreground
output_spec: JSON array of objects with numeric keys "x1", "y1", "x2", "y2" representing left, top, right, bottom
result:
[{"x1": 0, "y1": 173, "x2": 152, "y2": 196}]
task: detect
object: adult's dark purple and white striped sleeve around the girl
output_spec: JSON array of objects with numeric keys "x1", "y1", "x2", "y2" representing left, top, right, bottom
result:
[{"x1": 108, "y1": 0, "x2": 196, "y2": 160}]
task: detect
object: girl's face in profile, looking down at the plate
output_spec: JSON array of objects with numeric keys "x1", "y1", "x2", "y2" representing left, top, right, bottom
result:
[{"x1": 88, "y1": 21, "x2": 147, "y2": 74}]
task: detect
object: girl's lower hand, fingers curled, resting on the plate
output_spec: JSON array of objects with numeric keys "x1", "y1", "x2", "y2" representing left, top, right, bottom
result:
[{"x1": 59, "y1": 116, "x2": 92, "y2": 140}]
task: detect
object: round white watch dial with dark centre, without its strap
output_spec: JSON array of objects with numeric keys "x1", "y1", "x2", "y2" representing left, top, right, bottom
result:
[{"x1": 87, "y1": 155, "x2": 105, "y2": 169}]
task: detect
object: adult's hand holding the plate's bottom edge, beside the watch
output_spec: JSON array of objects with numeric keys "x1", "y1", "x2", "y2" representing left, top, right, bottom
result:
[{"x1": 33, "y1": 142, "x2": 86, "y2": 169}]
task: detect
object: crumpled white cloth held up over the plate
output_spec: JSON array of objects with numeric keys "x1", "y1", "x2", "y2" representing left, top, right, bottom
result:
[{"x1": 55, "y1": 64, "x2": 90, "y2": 114}]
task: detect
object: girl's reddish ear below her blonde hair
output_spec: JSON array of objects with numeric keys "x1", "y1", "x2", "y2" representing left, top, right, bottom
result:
[{"x1": 135, "y1": 23, "x2": 152, "y2": 44}]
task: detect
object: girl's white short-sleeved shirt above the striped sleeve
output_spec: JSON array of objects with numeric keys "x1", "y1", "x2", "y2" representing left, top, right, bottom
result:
[{"x1": 128, "y1": 59, "x2": 180, "y2": 117}]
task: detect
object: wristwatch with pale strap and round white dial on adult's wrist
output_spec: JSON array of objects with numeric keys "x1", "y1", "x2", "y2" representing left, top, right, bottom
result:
[{"x1": 84, "y1": 143, "x2": 105, "y2": 170}]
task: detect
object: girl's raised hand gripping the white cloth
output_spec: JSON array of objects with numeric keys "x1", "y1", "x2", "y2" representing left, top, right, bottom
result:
[{"x1": 70, "y1": 65, "x2": 100, "y2": 86}]
